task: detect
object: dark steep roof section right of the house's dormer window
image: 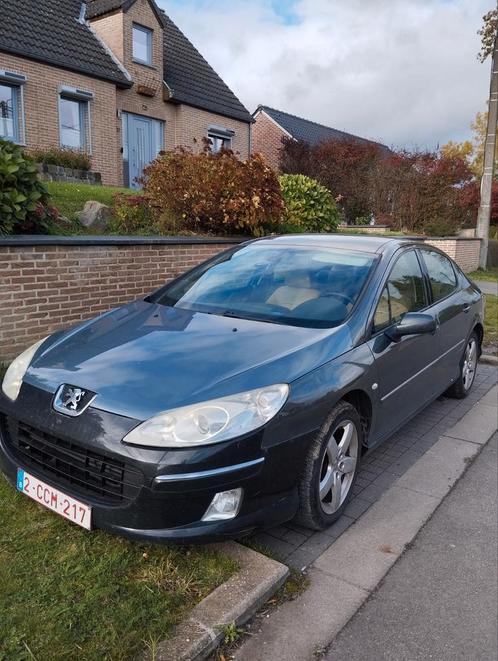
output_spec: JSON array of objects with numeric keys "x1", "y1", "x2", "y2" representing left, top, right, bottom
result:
[{"x1": 161, "y1": 12, "x2": 252, "y2": 123}]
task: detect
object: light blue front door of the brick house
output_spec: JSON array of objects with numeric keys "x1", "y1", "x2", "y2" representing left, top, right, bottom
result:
[{"x1": 124, "y1": 113, "x2": 163, "y2": 188}]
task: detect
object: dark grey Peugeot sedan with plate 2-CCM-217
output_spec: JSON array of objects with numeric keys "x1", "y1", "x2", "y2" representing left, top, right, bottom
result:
[{"x1": 0, "y1": 235, "x2": 483, "y2": 543}]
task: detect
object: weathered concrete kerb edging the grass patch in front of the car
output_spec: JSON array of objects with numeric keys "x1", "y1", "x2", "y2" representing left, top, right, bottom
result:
[{"x1": 148, "y1": 542, "x2": 290, "y2": 661}]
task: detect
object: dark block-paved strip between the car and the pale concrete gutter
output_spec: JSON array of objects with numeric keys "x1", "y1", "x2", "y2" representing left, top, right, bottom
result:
[{"x1": 252, "y1": 360, "x2": 498, "y2": 569}]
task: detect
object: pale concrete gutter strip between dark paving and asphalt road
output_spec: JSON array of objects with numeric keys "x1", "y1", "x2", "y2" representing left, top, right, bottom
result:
[{"x1": 234, "y1": 386, "x2": 498, "y2": 661}]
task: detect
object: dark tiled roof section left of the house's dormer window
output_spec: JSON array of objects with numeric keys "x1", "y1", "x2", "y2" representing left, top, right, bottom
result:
[{"x1": 0, "y1": 0, "x2": 131, "y2": 87}]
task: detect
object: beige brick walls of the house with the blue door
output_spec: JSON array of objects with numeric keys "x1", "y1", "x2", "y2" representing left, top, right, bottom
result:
[{"x1": 0, "y1": 0, "x2": 250, "y2": 186}]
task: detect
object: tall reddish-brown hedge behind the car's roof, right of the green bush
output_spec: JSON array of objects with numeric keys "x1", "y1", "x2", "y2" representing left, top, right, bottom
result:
[{"x1": 281, "y1": 139, "x2": 478, "y2": 235}]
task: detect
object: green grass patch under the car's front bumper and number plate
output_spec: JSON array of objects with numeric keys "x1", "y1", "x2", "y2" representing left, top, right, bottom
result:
[{"x1": 0, "y1": 477, "x2": 237, "y2": 661}]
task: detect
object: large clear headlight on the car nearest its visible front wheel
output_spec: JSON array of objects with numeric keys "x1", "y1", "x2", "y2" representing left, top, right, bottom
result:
[{"x1": 123, "y1": 383, "x2": 289, "y2": 448}]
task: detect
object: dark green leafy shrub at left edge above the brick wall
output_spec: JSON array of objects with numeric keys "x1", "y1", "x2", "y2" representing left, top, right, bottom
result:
[{"x1": 0, "y1": 138, "x2": 57, "y2": 234}]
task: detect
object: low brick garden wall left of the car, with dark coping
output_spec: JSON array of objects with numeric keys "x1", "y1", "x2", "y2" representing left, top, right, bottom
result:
[{"x1": 0, "y1": 237, "x2": 241, "y2": 363}]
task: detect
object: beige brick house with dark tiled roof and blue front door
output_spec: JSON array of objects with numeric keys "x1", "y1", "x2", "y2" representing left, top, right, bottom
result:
[{"x1": 0, "y1": 0, "x2": 252, "y2": 186}]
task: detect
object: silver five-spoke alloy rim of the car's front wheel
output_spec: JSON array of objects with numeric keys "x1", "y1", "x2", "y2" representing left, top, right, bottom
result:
[{"x1": 318, "y1": 420, "x2": 359, "y2": 514}]
